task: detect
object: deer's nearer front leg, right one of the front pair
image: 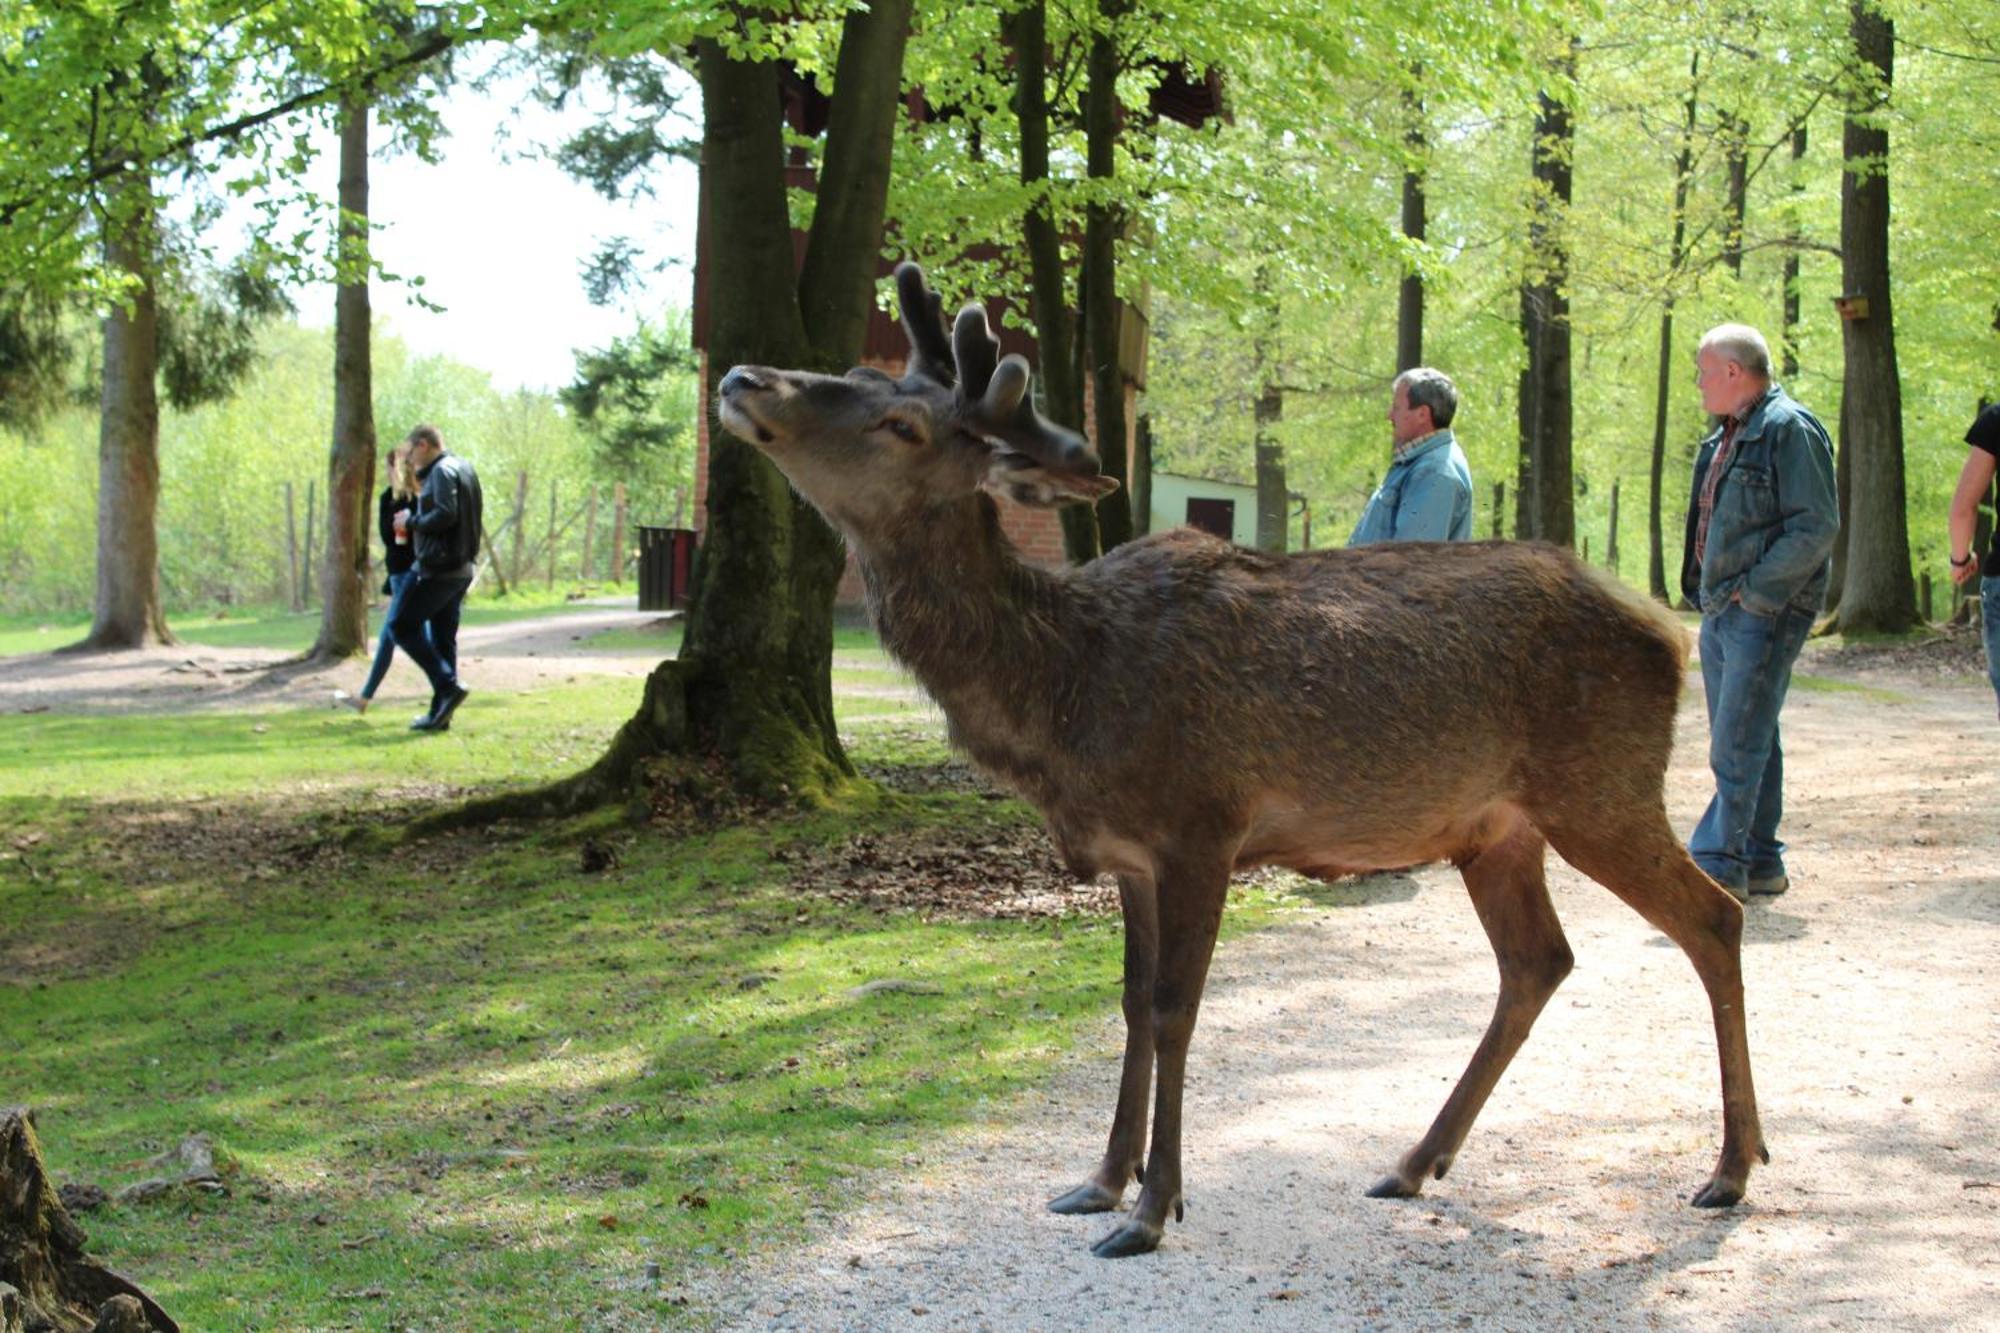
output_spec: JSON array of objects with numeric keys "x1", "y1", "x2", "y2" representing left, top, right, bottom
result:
[{"x1": 1090, "y1": 865, "x2": 1228, "y2": 1259}]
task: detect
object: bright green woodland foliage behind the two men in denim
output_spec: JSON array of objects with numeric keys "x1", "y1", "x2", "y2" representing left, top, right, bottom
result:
[{"x1": 1140, "y1": 0, "x2": 2000, "y2": 582}]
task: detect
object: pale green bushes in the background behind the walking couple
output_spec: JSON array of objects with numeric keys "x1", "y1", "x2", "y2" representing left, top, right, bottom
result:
[{"x1": 0, "y1": 322, "x2": 694, "y2": 616}]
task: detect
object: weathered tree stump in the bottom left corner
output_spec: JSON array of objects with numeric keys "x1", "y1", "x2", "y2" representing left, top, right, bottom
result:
[{"x1": 0, "y1": 1107, "x2": 180, "y2": 1333}]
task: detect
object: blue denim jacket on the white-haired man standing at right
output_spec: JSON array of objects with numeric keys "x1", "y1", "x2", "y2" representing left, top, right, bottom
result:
[{"x1": 1680, "y1": 384, "x2": 1840, "y2": 616}]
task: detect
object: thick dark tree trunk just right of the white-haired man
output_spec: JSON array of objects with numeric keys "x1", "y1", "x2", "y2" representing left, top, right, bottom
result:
[{"x1": 1838, "y1": 0, "x2": 1916, "y2": 632}]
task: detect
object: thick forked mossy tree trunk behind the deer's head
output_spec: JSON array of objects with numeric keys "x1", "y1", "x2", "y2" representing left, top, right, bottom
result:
[{"x1": 438, "y1": 0, "x2": 910, "y2": 823}]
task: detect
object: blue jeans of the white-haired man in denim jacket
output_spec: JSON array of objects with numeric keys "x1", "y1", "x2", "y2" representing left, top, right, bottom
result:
[{"x1": 1688, "y1": 602, "x2": 1812, "y2": 891}]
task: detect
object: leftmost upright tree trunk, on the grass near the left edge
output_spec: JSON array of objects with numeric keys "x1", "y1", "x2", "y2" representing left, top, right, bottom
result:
[{"x1": 76, "y1": 174, "x2": 174, "y2": 650}]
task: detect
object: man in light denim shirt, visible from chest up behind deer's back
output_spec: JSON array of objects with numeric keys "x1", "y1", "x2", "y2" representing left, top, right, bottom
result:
[{"x1": 1348, "y1": 366, "x2": 1472, "y2": 546}]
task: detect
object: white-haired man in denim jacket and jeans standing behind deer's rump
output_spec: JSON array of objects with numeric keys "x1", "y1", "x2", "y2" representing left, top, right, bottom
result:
[{"x1": 1680, "y1": 324, "x2": 1840, "y2": 903}]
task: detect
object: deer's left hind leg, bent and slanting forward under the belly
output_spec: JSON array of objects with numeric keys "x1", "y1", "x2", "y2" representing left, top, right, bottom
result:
[{"x1": 1368, "y1": 817, "x2": 1574, "y2": 1199}]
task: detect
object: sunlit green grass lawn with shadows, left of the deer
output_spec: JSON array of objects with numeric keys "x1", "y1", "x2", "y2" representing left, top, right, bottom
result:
[{"x1": 0, "y1": 640, "x2": 1284, "y2": 1329}]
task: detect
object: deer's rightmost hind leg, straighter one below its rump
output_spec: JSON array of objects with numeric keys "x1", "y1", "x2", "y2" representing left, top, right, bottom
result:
[{"x1": 1548, "y1": 811, "x2": 1770, "y2": 1209}]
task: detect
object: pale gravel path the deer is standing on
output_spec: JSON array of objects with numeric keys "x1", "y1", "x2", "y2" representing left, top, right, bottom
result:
[{"x1": 682, "y1": 658, "x2": 2000, "y2": 1333}]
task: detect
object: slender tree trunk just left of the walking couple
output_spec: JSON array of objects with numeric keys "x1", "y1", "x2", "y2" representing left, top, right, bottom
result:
[{"x1": 310, "y1": 98, "x2": 376, "y2": 662}]
